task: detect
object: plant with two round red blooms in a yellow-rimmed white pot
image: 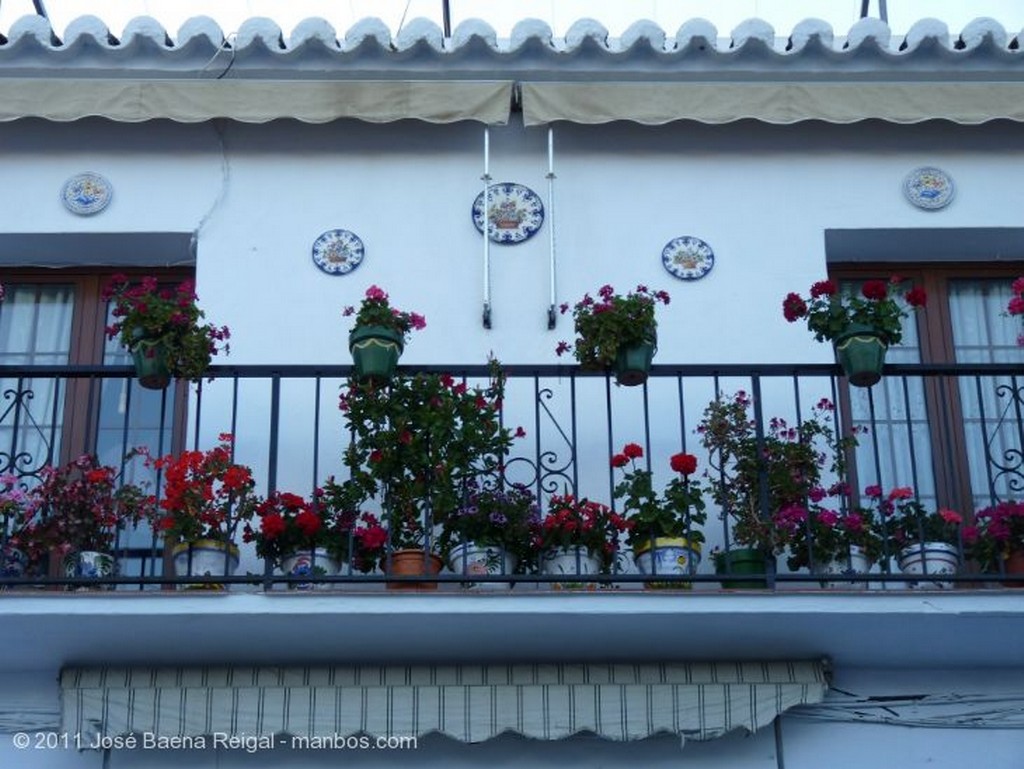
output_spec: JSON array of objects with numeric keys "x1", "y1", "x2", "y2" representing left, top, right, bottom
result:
[{"x1": 611, "y1": 443, "x2": 708, "y2": 587}]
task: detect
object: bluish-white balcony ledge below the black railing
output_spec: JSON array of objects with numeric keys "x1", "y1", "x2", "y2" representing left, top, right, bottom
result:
[{"x1": 0, "y1": 590, "x2": 1024, "y2": 673}]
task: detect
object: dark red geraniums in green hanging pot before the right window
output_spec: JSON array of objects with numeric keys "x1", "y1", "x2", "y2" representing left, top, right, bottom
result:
[{"x1": 782, "y1": 275, "x2": 928, "y2": 387}]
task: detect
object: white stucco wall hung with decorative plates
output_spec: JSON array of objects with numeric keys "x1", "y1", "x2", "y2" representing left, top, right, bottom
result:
[{"x1": 0, "y1": 114, "x2": 1024, "y2": 569}]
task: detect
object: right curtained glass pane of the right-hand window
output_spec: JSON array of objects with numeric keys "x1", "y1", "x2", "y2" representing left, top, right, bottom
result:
[{"x1": 949, "y1": 280, "x2": 1024, "y2": 508}]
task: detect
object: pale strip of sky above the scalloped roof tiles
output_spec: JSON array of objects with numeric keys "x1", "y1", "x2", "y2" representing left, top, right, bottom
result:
[{"x1": 0, "y1": 0, "x2": 1024, "y2": 39}]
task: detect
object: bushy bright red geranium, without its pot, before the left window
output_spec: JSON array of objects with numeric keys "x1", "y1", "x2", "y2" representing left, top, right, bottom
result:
[{"x1": 147, "y1": 433, "x2": 259, "y2": 543}]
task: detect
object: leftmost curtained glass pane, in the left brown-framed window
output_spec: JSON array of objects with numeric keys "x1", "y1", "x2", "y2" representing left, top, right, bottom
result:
[{"x1": 0, "y1": 284, "x2": 75, "y2": 474}]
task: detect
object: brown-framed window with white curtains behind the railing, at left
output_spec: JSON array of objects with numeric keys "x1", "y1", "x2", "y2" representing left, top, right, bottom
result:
[{"x1": 0, "y1": 269, "x2": 186, "y2": 575}]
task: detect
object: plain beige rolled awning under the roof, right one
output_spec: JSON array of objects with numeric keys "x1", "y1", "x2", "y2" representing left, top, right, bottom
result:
[{"x1": 522, "y1": 82, "x2": 1024, "y2": 126}]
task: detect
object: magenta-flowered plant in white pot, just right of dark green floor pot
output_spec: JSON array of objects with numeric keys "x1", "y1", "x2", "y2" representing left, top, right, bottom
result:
[{"x1": 773, "y1": 499, "x2": 882, "y2": 588}]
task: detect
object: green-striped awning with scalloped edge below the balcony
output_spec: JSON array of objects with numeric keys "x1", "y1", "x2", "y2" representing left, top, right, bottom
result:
[{"x1": 60, "y1": 661, "x2": 827, "y2": 742}]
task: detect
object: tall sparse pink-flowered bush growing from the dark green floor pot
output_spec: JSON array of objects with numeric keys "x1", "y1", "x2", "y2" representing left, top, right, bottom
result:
[{"x1": 696, "y1": 390, "x2": 857, "y2": 554}]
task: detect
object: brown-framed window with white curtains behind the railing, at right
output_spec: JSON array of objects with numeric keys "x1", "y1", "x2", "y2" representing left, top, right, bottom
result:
[{"x1": 833, "y1": 264, "x2": 1024, "y2": 518}]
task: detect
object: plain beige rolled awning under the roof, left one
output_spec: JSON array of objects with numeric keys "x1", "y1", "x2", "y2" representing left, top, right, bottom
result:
[{"x1": 0, "y1": 78, "x2": 512, "y2": 125}]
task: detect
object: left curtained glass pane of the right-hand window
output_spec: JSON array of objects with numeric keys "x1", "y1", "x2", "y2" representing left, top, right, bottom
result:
[{"x1": 844, "y1": 283, "x2": 936, "y2": 506}]
